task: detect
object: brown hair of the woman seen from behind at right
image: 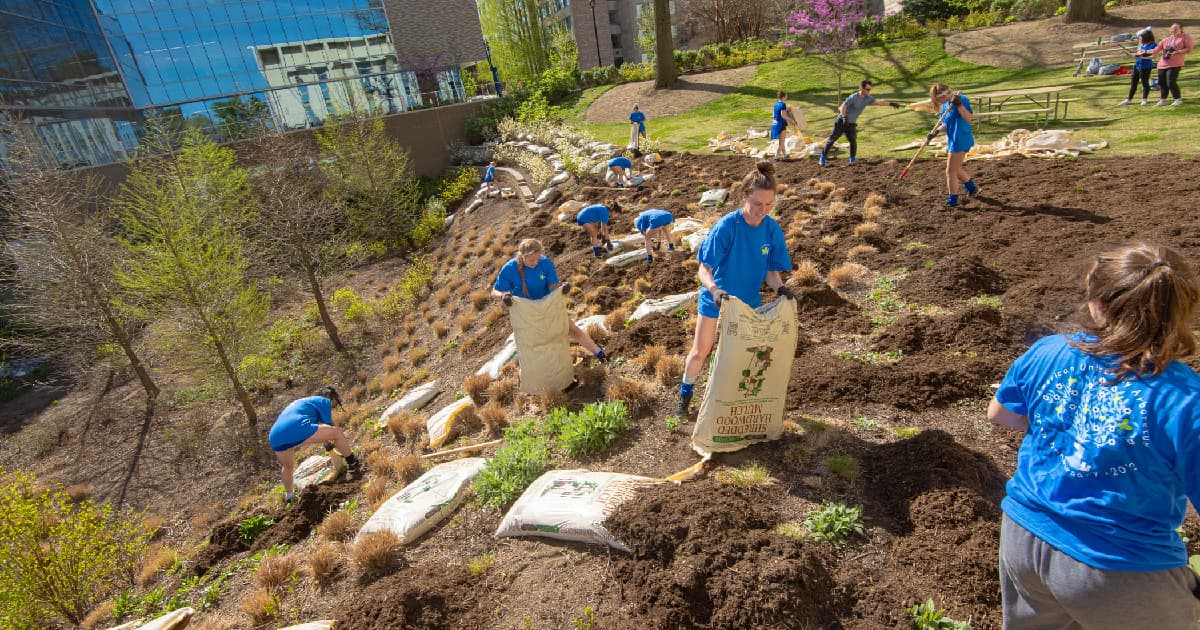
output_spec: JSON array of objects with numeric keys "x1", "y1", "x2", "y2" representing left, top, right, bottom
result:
[{"x1": 1074, "y1": 242, "x2": 1200, "y2": 383}]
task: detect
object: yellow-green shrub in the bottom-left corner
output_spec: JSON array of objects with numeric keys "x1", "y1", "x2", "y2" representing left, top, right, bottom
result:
[{"x1": 0, "y1": 468, "x2": 149, "y2": 629}]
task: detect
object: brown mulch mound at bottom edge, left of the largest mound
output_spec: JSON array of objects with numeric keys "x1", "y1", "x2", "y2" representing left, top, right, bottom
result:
[{"x1": 335, "y1": 564, "x2": 491, "y2": 630}]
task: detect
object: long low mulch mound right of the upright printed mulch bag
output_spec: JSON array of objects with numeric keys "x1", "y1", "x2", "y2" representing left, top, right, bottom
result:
[{"x1": 787, "y1": 350, "x2": 993, "y2": 410}]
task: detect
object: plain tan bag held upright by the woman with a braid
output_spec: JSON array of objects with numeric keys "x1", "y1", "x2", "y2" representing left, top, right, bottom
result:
[{"x1": 509, "y1": 290, "x2": 575, "y2": 394}]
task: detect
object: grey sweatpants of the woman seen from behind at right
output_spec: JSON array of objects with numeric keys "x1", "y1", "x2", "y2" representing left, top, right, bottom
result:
[{"x1": 1000, "y1": 515, "x2": 1200, "y2": 630}]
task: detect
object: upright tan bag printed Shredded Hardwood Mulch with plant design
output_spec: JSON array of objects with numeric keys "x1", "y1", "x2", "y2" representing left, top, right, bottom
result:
[{"x1": 691, "y1": 295, "x2": 797, "y2": 457}]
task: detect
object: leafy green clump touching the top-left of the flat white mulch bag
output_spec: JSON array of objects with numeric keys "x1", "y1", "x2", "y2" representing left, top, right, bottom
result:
[{"x1": 475, "y1": 419, "x2": 550, "y2": 510}]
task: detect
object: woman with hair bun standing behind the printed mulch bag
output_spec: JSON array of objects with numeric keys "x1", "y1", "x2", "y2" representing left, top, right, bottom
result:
[{"x1": 676, "y1": 161, "x2": 793, "y2": 418}]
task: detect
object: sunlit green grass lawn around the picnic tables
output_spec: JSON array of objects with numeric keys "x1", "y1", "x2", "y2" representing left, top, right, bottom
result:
[{"x1": 569, "y1": 38, "x2": 1200, "y2": 156}]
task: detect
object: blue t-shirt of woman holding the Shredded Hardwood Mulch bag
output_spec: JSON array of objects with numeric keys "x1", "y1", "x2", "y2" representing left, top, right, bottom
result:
[{"x1": 696, "y1": 209, "x2": 792, "y2": 317}]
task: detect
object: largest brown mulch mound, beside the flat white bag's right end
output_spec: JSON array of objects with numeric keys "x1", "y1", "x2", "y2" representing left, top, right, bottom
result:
[{"x1": 606, "y1": 480, "x2": 845, "y2": 630}]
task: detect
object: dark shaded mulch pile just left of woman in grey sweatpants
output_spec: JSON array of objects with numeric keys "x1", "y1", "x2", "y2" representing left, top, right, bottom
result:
[{"x1": 863, "y1": 430, "x2": 1004, "y2": 533}]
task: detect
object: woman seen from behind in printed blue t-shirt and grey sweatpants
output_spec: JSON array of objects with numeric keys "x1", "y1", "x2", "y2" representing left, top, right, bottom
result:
[{"x1": 988, "y1": 244, "x2": 1200, "y2": 630}]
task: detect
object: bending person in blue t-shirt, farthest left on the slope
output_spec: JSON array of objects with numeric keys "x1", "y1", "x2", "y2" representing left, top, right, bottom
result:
[{"x1": 268, "y1": 388, "x2": 359, "y2": 503}]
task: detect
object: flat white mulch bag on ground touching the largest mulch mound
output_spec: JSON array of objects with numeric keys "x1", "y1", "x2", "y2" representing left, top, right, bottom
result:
[{"x1": 496, "y1": 470, "x2": 655, "y2": 552}]
